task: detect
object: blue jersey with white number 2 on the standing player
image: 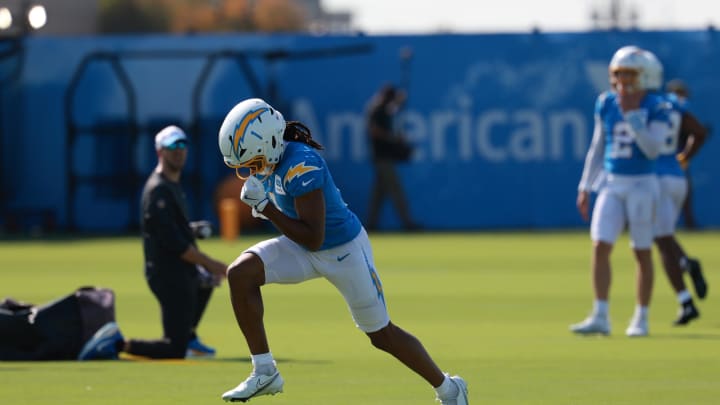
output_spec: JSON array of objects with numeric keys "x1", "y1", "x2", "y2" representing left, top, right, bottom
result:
[{"x1": 595, "y1": 92, "x2": 670, "y2": 175}]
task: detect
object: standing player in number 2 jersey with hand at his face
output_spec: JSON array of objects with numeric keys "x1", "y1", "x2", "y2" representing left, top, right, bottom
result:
[{"x1": 570, "y1": 47, "x2": 669, "y2": 337}]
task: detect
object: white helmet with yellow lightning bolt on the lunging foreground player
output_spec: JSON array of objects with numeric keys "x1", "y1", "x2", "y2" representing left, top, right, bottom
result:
[{"x1": 218, "y1": 98, "x2": 285, "y2": 179}]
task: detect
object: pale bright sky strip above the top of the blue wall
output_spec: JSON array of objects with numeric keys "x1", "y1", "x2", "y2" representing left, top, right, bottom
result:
[{"x1": 322, "y1": 0, "x2": 720, "y2": 34}]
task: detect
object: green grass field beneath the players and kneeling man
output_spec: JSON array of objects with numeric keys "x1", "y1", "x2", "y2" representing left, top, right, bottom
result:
[{"x1": 0, "y1": 231, "x2": 720, "y2": 405}]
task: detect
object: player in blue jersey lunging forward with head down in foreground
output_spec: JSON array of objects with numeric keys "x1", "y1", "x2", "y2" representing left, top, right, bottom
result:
[{"x1": 218, "y1": 98, "x2": 468, "y2": 405}]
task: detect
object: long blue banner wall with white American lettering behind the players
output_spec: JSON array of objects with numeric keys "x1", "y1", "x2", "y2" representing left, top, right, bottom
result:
[{"x1": 0, "y1": 31, "x2": 720, "y2": 232}]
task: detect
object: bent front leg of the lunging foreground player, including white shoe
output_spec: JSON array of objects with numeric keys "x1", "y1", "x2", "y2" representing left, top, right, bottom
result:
[{"x1": 222, "y1": 236, "x2": 319, "y2": 402}]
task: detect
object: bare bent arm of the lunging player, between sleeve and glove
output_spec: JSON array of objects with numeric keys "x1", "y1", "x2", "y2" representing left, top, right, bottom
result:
[{"x1": 262, "y1": 188, "x2": 325, "y2": 251}]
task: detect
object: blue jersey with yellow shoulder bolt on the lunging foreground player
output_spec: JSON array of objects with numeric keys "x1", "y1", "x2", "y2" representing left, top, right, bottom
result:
[{"x1": 263, "y1": 142, "x2": 362, "y2": 250}]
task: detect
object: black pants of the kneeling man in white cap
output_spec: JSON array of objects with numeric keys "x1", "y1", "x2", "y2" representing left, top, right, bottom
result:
[{"x1": 129, "y1": 274, "x2": 213, "y2": 359}]
